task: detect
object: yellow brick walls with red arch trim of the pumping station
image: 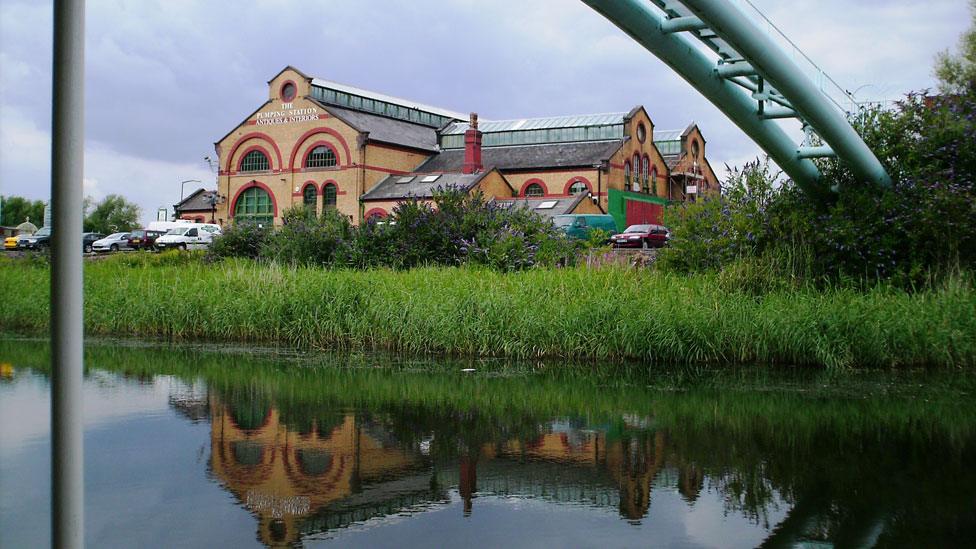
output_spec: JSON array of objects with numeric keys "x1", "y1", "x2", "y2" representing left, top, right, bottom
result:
[{"x1": 215, "y1": 67, "x2": 719, "y2": 224}]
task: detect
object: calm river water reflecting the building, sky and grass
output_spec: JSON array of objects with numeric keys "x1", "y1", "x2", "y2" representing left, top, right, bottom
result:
[{"x1": 0, "y1": 339, "x2": 976, "y2": 548}]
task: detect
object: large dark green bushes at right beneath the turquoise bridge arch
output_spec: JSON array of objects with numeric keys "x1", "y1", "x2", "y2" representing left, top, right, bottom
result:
[{"x1": 659, "y1": 83, "x2": 976, "y2": 287}]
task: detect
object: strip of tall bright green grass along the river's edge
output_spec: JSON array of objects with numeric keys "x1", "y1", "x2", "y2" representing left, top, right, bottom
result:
[{"x1": 0, "y1": 255, "x2": 976, "y2": 368}]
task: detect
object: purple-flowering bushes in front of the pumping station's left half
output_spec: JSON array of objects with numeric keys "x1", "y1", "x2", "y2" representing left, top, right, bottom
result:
[{"x1": 211, "y1": 189, "x2": 578, "y2": 271}]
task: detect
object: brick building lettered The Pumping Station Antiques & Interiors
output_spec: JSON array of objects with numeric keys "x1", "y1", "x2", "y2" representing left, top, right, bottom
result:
[{"x1": 212, "y1": 67, "x2": 719, "y2": 229}]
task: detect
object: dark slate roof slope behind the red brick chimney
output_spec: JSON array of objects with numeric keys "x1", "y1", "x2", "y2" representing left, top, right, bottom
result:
[{"x1": 417, "y1": 139, "x2": 623, "y2": 173}]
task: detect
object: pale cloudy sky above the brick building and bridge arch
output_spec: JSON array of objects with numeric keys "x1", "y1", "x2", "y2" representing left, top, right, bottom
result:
[{"x1": 0, "y1": 0, "x2": 971, "y2": 220}]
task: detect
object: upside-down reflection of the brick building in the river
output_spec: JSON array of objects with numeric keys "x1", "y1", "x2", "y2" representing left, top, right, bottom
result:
[{"x1": 204, "y1": 396, "x2": 704, "y2": 545}]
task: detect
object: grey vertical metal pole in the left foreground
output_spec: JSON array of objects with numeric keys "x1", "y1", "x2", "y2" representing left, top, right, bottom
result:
[{"x1": 51, "y1": 0, "x2": 85, "y2": 548}]
